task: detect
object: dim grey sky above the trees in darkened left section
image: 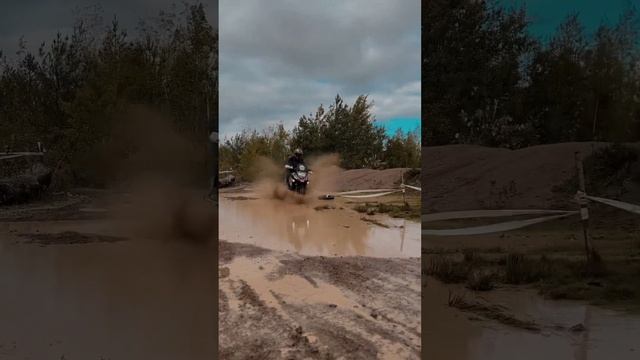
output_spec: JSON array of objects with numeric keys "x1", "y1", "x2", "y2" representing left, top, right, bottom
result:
[{"x1": 0, "y1": 0, "x2": 218, "y2": 57}]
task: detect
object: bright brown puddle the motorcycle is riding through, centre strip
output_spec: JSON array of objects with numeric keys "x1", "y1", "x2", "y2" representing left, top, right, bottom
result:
[{"x1": 219, "y1": 194, "x2": 420, "y2": 257}]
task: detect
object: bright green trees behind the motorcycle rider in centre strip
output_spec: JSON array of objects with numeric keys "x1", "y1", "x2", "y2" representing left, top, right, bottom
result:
[{"x1": 219, "y1": 95, "x2": 421, "y2": 178}]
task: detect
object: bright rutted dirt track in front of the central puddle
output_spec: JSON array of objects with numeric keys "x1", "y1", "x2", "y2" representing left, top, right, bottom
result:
[{"x1": 219, "y1": 242, "x2": 420, "y2": 359}]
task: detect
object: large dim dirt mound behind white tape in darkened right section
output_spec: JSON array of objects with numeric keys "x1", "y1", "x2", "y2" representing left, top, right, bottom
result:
[{"x1": 422, "y1": 142, "x2": 607, "y2": 212}]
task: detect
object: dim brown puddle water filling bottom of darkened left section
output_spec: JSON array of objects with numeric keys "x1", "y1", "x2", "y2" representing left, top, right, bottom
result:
[{"x1": 0, "y1": 221, "x2": 217, "y2": 360}]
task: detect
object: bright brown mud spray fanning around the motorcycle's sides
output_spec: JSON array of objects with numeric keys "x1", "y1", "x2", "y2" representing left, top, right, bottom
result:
[{"x1": 254, "y1": 154, "x2": 343, "y2": 205}]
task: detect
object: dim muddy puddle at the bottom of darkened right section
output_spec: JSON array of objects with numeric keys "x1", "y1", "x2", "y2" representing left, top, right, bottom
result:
[{"x1": 423, "y1": 278, "x2": 640, "y2": 360}]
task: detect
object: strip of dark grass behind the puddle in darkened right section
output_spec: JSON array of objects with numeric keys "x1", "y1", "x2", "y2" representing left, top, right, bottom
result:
[{"x1": 426, "y1": 250, "x2": 640, "y2": 304}]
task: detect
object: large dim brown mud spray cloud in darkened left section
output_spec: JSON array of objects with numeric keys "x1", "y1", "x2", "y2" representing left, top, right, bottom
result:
[{"x1": 98, "y1": 107, "x2": 217, "y2": 243}]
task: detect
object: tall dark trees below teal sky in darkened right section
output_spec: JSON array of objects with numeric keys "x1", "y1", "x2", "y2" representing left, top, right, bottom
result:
[{"x1": 422, "y1": 0, "x2": 640, "y2": 148}]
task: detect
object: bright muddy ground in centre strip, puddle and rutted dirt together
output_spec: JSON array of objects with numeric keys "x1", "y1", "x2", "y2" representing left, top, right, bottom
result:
[{"x1": 219, "y1": 184, "x2": 421, "y2": 359}]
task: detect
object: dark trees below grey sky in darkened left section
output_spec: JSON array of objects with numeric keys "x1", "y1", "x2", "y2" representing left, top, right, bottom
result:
[{"x1": 0, "y1": 3, "x2": 218, "y2": 184}]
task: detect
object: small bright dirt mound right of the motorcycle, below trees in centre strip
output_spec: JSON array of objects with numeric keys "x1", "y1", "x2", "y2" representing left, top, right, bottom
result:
[{"x1": 337, "y1": 168, "x2": 420, "y2": 191}]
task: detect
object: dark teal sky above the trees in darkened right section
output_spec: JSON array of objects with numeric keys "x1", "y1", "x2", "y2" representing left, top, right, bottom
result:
[{"x1": 498, "y1": 0, "x2": 640, "y2": 40}]
